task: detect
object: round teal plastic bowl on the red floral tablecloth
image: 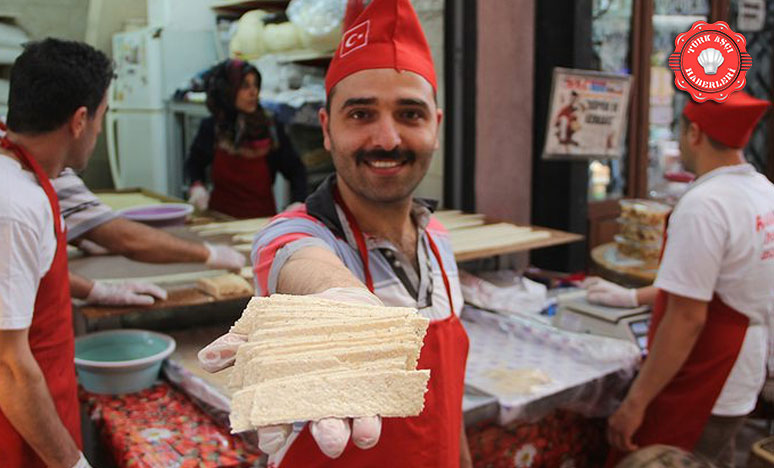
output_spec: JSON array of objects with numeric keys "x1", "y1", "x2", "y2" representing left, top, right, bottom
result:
[{"x1": 75, "y1": 329, "x2": 175, "y2": 395}]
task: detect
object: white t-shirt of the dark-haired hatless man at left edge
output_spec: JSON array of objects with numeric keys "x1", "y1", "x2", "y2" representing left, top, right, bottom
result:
[{"x1": 0, "y1": 154, "x2": 56, "y2": 330}]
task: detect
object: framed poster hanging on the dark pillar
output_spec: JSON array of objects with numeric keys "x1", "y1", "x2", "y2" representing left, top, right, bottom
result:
[{"x1": 543, "y1": 67, "x2": 631, "y2": 159}]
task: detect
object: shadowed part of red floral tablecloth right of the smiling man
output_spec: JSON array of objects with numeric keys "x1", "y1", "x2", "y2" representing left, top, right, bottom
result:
[{"x1": 467, "y1": 411, "x2": 608, "y2": 468}]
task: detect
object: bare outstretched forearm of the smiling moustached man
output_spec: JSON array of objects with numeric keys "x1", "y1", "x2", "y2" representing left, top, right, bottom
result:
[{"x1": 277, "y1": 247, "x2": 365, "y2": 294}]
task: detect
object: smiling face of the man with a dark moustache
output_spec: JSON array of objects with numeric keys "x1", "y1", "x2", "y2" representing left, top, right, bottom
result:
[{"x1": 320, "y1": 69, "x2": 442, "y2": 203}]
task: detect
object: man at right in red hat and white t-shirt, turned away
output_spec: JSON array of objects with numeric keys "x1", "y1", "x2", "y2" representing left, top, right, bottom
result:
[{"x1": 604, "y1": 92, "x2": 774, "y2": 466}]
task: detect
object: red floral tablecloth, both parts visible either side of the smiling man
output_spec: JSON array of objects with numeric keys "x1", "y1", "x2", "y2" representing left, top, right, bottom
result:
[{"x1": 85, "y1": 382, "x2": 607, "y2": 468}]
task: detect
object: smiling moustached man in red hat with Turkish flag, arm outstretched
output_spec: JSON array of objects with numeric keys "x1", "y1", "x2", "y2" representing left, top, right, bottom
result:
[{"x1": 199, "y1": 0, "x2": 470, "y2": 468}]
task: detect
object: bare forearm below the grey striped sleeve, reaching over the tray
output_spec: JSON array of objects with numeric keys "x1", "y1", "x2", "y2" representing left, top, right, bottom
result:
[{"x1": 83, "y1": 218, "x2": 209, "y2": 263}]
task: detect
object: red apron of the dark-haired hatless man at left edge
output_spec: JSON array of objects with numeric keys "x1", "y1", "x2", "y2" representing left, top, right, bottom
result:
[{"x1": 0, "y1": 138, "x2": 81, "y2": 468}]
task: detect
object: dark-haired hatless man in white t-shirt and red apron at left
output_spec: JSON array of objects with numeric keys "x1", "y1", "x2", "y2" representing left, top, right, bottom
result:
[{"x1": 0, "y1": 38, "x2": 113, "y2": 468}]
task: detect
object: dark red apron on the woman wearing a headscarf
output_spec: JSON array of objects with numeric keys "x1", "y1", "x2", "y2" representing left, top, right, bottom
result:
[{"x1": 209, "y1": 140, "x2": 277, "y2": 218}]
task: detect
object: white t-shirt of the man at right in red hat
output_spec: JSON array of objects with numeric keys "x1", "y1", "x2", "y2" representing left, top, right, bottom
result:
[{"x1": 655, "y1": 164, "x2": 774, "y2": 416}]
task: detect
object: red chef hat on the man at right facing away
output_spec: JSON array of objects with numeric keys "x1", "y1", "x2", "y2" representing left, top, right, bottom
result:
[{"x1": 683, "y1": 91, "x2": 769, "y2": 148}]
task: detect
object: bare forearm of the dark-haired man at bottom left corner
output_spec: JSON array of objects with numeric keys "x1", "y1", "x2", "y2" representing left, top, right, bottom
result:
[{"x1": 0, "y1": 348, "x2": 79, "y2": 468}]
